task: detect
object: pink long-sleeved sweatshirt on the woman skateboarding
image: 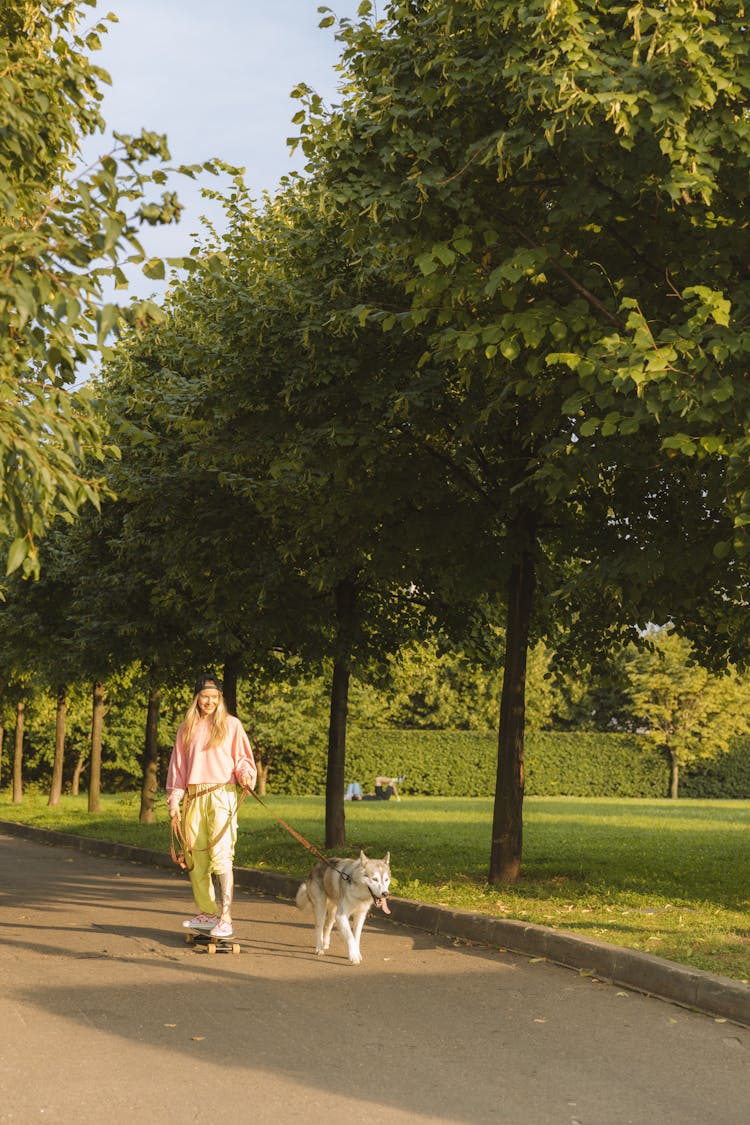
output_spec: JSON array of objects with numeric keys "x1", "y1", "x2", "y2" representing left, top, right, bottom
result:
[{"x1": 166, "y1": 716, "x2": 257, "y2": 815}]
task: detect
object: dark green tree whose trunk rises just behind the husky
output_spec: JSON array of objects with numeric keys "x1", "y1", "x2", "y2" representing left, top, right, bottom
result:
[{"x1": 117, "y1": 177, "x2": 436, "y2": 847}]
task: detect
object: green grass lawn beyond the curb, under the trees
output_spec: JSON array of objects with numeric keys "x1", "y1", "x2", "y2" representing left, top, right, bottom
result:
[{"x1": 0, "y1": 794, "x2": 750, "y2": 981}]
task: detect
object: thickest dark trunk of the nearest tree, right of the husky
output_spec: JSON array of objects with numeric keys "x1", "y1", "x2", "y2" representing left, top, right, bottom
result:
[{"x1": 488, "y1": 526, "x2": 534, "y2": 883}]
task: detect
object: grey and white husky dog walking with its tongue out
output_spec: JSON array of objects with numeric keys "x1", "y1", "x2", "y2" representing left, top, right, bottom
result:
[{"x1": 297, "y1": 852, "x2": 390, "y2": 965}]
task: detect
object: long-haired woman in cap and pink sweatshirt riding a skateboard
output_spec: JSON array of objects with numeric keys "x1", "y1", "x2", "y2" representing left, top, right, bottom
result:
[{"x1": 166, "y1": 674, "x2": 257, "y2": 938}]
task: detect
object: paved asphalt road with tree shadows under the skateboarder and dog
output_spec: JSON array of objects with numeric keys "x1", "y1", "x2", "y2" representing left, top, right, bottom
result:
[{"x1": 0, "y1": 835, "x2": 750, "y2": 1125}]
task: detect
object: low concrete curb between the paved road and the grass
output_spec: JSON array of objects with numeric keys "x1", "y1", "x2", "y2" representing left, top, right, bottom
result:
[{"x1": 0, "y1": 820, "x2": 750, "y2": 1027}]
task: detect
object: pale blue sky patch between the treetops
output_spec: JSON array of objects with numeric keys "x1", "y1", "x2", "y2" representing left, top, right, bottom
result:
[{"x1": 87, "y1": 0, "x2": 360, "y2": 299}]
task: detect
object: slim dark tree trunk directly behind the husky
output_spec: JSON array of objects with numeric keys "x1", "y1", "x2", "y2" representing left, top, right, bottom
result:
[{"x1": 325, "y1": 578, "x2": 356, "y2": 847}]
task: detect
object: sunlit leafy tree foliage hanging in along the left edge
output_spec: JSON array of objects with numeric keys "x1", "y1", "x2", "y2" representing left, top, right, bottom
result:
[{"x1": 0, "y1": 0, "x2": 214, "y2": 574}]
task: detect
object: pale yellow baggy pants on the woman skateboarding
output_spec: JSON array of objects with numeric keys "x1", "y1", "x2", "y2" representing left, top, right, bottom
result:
[{"x1": 182, "y1": 785, "x2": 237, "y2": 914}]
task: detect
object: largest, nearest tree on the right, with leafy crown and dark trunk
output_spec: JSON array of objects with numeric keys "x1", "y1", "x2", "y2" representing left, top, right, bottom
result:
[{"x1": 297, "y1": 0, "x2": 750, "y2": 882}]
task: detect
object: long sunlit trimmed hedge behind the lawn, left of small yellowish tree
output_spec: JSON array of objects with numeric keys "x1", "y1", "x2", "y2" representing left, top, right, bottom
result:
[{"x1": 269, "y1": 728, "x2": 674, "y2": 798}]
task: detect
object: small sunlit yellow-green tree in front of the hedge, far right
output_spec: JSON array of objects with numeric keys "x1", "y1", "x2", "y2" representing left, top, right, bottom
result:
[{"x1": 627, "y1": 630, "x2": 750, "y2": 799}]
